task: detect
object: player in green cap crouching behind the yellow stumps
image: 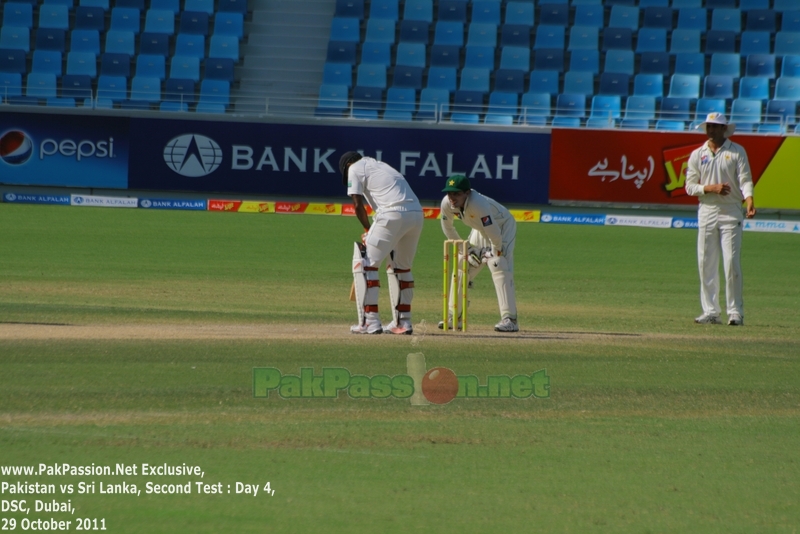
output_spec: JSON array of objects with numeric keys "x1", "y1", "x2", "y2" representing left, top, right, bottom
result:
[{"x1": 439, "y1": 174, "x2": 519, "y2": 332}]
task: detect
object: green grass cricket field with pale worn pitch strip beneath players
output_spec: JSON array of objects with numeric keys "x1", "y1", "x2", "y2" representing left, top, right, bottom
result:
[{"x1": 0, "y1": 204, "x2": 800, "y2": 533}]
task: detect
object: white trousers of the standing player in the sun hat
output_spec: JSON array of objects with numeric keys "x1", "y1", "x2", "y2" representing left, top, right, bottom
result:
[{"x1": 697, "y1": 204, "x2": 744, "y2": 317}]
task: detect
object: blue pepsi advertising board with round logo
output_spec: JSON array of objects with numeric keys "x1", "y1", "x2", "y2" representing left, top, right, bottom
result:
[{"x1": 0, "y1": 113, "x2": 129, "y2": 189}]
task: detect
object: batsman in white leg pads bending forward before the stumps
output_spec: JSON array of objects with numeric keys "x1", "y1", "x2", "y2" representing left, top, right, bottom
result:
[{"x1": 339, "y1": 152, "x2": 423, "y2": 334}]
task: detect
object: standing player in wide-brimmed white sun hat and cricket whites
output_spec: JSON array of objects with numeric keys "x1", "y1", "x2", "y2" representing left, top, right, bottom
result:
[{"x1": 686, "y1": 113, "x2": 756, "y2": 326}]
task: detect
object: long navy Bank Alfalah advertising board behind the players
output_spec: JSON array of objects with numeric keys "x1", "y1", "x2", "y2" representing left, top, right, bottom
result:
[{"x1": 128, "y1": 118, "x2": 550, "y2": 204}]
